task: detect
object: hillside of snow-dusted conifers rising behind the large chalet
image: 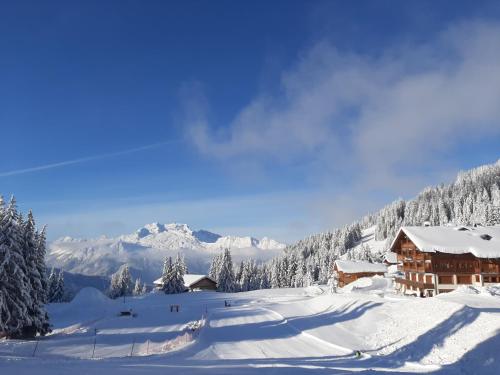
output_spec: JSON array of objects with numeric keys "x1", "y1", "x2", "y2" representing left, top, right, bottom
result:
[{"x1": 269, "y1": 160, "x2": 500, "y2": 288}]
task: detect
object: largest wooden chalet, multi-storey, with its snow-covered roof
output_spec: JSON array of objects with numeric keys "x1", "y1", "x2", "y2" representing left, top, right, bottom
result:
[{"x1": 390, "y1": 226, "x2": 500, "y2": 296}]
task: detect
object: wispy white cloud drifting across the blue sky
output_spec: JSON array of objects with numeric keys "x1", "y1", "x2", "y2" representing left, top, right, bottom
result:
[{"x1": 188, "y1": 22, "x2": 500, "y2": 192}]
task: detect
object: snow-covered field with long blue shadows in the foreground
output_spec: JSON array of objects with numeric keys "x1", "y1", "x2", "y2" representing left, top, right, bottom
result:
[{"x1": 0, "y1": 277, "x2": 500, "y2": 375}]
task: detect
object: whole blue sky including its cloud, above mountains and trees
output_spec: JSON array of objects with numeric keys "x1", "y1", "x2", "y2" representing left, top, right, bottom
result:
[{"x1": 0, "y1": 1, "x2": 500, "y2": 242}]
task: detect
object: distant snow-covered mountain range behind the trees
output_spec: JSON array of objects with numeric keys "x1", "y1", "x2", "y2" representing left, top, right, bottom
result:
[{"x1": 47, "y1": 223, "x2": 285, "y2": 282}]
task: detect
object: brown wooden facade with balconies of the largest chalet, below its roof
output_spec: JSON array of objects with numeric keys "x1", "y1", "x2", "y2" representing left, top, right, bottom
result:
[{"x1": 391, "y1": 230, "x2": 500, "y2": 296}]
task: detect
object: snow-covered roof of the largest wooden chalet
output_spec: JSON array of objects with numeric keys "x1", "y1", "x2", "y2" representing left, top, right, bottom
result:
[{"x1": 391, "y1": 225, "x2": 500, "y2": 258}]
